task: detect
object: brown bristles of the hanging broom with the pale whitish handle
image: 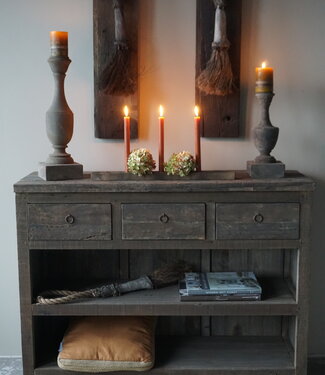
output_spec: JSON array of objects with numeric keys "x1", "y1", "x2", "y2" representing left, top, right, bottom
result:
[{"x1": 197, "y1": 47, "x2": 234, "y2": 96}]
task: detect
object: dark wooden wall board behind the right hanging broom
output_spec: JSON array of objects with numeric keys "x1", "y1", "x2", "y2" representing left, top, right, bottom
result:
[{"x1": 196, "y1": 0, "x2": 241, "y2": 138}]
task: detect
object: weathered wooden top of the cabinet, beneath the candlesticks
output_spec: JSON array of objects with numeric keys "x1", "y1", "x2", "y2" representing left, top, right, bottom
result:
[{"x1": 14, "y1": 171, "x2": 315, "y2": 193}]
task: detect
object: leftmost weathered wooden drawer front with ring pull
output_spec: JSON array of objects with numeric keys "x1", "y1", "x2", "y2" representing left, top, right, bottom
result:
[{"x1": 28, "y1": 203, "x2": 112, "y2": 241}]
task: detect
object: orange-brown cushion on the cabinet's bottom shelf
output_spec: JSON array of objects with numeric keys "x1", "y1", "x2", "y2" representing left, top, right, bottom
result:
[{"x1": 58, "y1": 316, "x2": 155, "y2": 372}]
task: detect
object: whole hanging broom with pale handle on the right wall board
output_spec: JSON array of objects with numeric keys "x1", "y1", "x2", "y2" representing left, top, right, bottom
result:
[{"x1": 197, "y1": 0, "x2": 234, "y2": 96}]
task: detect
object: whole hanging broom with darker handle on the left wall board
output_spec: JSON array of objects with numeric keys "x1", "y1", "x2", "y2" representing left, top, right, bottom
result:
[{"x1": 99, "y1": 0, "x2": 137, "y2": 96}]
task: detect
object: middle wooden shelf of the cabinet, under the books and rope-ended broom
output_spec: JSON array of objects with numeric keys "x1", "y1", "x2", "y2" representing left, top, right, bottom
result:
[{"x1": 32, "y1": 280, "x2": 298, "y2": 318}]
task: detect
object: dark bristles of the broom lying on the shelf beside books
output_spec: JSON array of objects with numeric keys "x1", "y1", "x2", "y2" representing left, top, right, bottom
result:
[{"x1": 149, "y1": 260, "x2": 191, "y2": 288}]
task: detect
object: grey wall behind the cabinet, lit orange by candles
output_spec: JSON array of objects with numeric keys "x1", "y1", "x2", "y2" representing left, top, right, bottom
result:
[{"x1": 0, "y1": 0, "x2": 325, "y2": 356}]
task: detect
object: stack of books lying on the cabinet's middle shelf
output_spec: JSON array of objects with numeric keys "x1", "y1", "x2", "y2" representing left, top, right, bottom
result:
[{"x1": 179, "y1": 272, "x2": 262, "y2": 301}]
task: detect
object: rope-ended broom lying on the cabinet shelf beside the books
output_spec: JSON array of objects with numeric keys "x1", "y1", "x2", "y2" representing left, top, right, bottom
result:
[{"x1": 36, "y1": 261, "x2": 191, "y2": 305}]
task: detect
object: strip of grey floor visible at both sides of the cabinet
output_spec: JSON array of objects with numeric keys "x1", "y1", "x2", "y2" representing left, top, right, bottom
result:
[{"x1": 0, "y1": 358, "x2": 325, "y2": 375}]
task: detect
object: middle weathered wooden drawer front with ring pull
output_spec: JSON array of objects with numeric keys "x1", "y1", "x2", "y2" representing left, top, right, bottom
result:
[{"x1": 122, "y1": 203, "x2": 205, "y2": 240}]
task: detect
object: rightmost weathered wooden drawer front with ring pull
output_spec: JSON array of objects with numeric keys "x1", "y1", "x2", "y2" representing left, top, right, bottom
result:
[{"x1": 216, "y1": 203, "x2": 299, "y2": 240}]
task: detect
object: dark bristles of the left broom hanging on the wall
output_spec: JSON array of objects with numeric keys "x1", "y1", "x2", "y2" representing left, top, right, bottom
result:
[{"x1": 99, "y1": 45, "x2": 137, "y2": 96}]
